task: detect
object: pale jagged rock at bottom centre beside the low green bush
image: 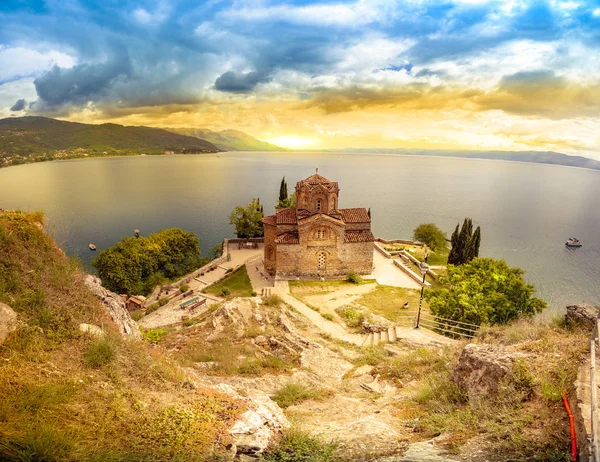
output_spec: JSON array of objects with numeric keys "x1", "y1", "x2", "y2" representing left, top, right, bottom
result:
[{"x1": 215, "y1": 384, "x2": 290, "y2": 460}]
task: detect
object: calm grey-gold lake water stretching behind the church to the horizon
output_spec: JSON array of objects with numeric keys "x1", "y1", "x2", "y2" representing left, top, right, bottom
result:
[{"x1": 0, "y1": 153, "x2": 600, "y2": 307}]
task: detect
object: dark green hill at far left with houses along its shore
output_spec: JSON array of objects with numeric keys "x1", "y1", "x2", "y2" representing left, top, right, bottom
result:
[{"x1": 0, "y1": 117, "x2": 221, "y2": 163}]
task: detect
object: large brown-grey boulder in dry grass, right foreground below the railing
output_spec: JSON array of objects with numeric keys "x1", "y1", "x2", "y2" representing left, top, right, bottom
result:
[{"x1": 452, "y1": 343, "x2": 527, "y2": 399}]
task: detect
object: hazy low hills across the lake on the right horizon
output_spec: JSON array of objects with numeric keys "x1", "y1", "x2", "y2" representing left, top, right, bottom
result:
[{"x1": 336, "y1": 149, "x2": 600, "y2": 170}]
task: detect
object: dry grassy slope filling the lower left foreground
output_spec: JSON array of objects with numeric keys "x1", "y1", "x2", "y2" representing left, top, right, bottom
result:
[{"x1": 0, "y1": 213, "x2": 244, "y2": 461}]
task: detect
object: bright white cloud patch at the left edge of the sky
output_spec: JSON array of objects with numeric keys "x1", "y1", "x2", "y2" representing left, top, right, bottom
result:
[{"x1": 0, "y1": 45, "x2": 75, "y2": 83}]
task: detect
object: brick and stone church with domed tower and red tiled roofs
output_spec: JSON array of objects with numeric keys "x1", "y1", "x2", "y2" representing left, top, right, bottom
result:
[{"x1": 263, "y1": 170, "x2": 375, "y2": 278}]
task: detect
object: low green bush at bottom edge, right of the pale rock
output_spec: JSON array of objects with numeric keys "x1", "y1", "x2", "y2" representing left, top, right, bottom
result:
[{"x1": 264, "y1": 429, "x2": 340, "y2": 462}]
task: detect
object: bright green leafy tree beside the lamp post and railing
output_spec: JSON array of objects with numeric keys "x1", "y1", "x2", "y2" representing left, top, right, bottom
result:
[{"x1": 425, "y1": 258, "x2": 546, "y2": 326}]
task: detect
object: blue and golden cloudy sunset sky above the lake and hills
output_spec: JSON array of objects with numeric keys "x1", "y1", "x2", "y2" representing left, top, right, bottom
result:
[{"x1": 0, "y1": 0, "x2": 600, "y2": 155}]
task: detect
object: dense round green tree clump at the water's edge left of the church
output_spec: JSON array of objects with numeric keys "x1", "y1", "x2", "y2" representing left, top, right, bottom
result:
[{"x1": 92, "y1": 228, "x2": 204, "y2": 295}]
